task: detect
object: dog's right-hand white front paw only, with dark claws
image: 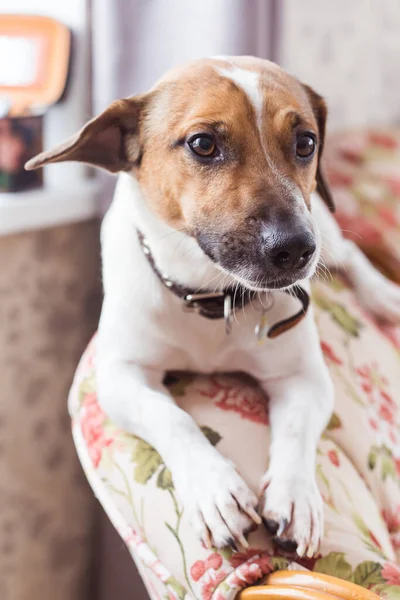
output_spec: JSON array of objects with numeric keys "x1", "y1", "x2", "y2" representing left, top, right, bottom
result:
[{"x1": 259, "y1": 472, "x2": 323, "y2": 557}]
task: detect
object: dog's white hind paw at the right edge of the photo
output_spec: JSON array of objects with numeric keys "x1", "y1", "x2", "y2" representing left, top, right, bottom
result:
[{"x1": 357, "y1": 274, "x2": 400, "y2": 325}]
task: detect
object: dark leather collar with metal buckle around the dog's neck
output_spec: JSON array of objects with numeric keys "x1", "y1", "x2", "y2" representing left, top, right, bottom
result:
[{"x1": 137, "y1": 230, "x2": 310, "y2": 338}]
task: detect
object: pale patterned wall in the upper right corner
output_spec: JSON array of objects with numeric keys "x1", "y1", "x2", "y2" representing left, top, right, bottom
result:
[{"x1": 279, "y1": 0, "x2": 400, "y2": 130}]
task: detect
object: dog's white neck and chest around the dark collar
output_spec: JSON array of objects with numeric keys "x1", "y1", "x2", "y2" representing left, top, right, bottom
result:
[{"x1": 101, "y1": 185, "x2": 309, "y2": 376}]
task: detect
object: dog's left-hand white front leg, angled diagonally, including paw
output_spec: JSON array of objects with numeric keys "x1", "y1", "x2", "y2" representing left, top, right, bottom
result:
[{"x1": 97, "y1": 361, "x2": 261, "y2": 549}]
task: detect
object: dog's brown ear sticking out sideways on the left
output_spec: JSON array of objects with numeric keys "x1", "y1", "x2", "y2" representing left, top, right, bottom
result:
[{"x1": 25, "y1": 96, "x2": 146, "y2": 173}]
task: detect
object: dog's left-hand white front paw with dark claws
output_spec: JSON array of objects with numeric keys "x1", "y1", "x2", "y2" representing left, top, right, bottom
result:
[{"x1": 175, "y1": 455, "x2": 261, "y2": 550}]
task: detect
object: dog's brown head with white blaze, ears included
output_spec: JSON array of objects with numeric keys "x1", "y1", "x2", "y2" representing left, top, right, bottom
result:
[{"x1": 27, "y1": 57, "x2": 333, "y2": 289}]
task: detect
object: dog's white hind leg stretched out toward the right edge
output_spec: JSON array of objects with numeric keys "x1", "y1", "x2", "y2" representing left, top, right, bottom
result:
[{"x1": 313, "y1": 198, "x2": 400, "y2": 324}]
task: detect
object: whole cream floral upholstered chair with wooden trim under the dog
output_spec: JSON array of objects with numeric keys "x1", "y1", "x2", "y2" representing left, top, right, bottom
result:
[{"x1": 70, "y1": 131, "x2": 400, "y2": 600}]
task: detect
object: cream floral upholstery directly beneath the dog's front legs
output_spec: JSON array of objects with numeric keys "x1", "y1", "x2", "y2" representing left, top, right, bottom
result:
[{"x1": 70, "y1": 279, "x2": 400, "y2": 600}]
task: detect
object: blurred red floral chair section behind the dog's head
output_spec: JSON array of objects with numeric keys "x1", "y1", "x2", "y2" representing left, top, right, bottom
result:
[{"x1": 325, "y1": 129, "x2": 400, "y2": 292}]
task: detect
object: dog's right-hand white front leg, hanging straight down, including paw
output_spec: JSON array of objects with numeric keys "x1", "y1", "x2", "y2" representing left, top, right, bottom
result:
[{"x1": 260, "y1": 360, "x2": 333, "y2": 556}]
